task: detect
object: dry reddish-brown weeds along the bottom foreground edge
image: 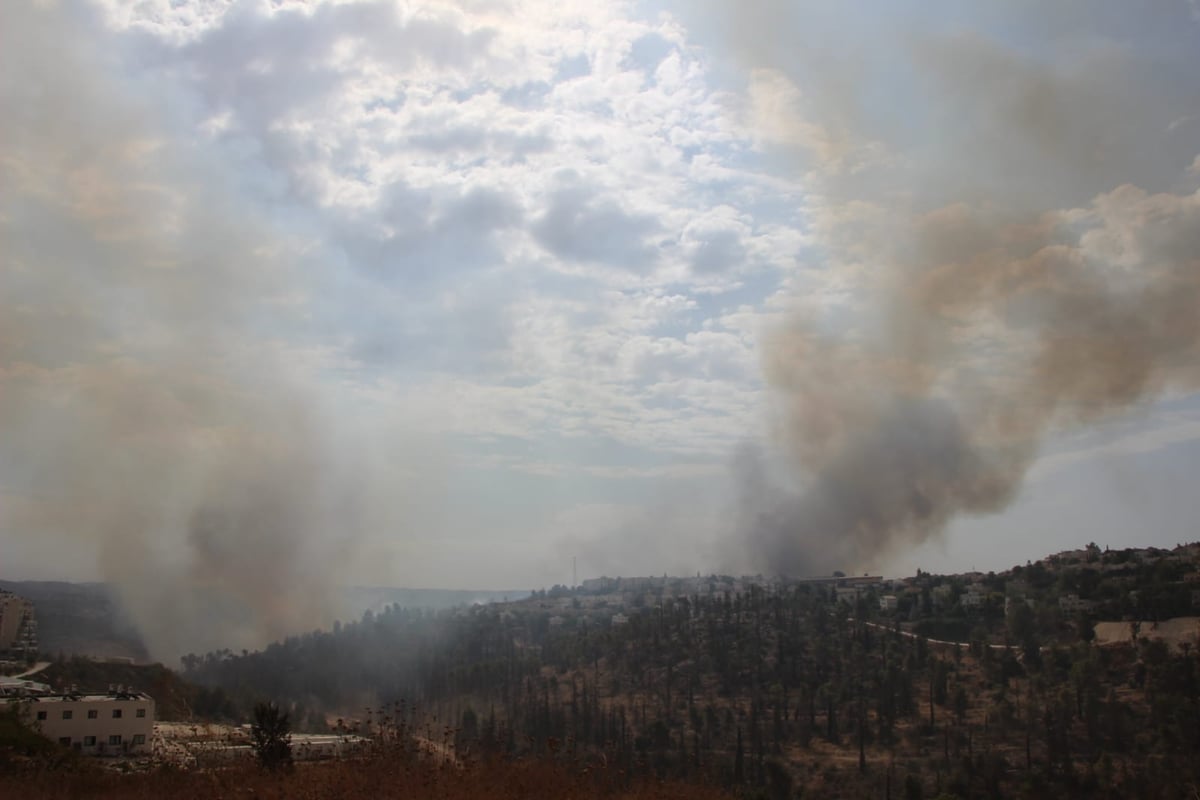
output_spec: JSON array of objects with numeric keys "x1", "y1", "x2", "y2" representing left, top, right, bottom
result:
[{"x1": 0, "y1": 754, "x2": 730, "y2": 800}]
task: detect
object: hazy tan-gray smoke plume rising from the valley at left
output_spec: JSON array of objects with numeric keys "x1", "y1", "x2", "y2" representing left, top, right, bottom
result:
[{"x1": 0, "y1": 4, "x2": 403, "y2": 658}]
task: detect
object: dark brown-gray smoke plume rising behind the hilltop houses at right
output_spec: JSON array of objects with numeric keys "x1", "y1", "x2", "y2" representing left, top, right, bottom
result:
[{"x1": 710, "y1": 2, "x2": 1200, "y2": 575}]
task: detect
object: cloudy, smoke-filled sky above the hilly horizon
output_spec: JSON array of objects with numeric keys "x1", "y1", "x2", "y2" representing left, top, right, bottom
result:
[{"x1": 0, "y1": 0, "x2": 1200, "y2": 648}]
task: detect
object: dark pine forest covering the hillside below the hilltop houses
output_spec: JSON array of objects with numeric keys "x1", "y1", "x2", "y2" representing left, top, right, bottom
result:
[{"x1": 175, "y1": 551, "x2": 1200, "y2": 798}]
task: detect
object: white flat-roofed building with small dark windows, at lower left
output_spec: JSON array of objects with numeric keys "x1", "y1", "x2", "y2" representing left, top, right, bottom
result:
[{"x1": 8, "y1": 691, "x2": 154, "y2": 756}]
